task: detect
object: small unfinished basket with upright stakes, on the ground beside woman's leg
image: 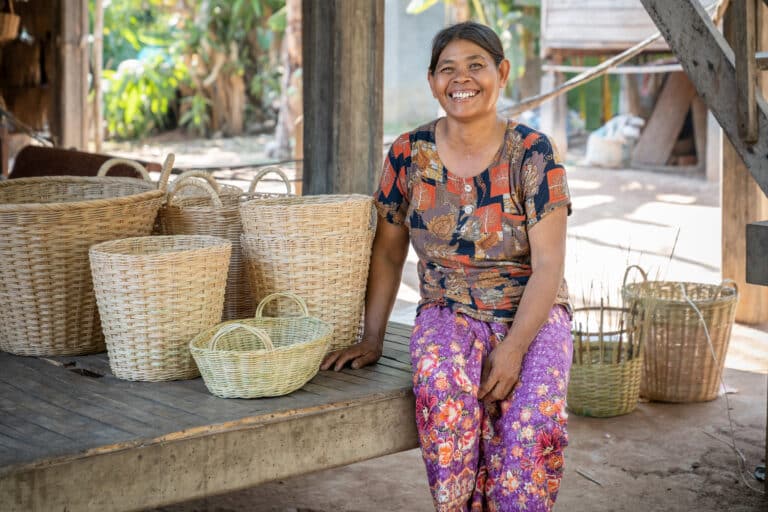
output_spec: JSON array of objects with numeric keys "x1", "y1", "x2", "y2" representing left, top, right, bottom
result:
[{"x1": 567, "y1": 305, "x2": 643, "y2": 418}]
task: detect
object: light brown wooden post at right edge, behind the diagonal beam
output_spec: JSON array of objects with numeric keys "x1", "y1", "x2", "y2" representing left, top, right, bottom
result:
[{"x1": 721, "y1": 2, "x2": 768, "y2": 324}]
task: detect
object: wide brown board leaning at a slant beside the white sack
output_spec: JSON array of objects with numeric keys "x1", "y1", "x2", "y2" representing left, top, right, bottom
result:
[{"x1": 632, "y1": 73, "x2": 696, "y2": 166}]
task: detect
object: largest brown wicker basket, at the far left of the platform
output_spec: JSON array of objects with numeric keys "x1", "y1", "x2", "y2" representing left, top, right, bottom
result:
[{"x1": 0, "y1": 176, "x2": 163, "y2": 356}]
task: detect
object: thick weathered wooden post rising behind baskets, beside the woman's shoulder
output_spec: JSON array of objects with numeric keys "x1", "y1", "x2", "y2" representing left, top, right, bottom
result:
[{"x1": 302, "y1": 0, "x2": 384, "y2": 194}]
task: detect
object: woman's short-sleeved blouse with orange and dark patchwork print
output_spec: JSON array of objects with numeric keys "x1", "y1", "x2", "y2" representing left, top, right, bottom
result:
[{"x1": 374, "y1": 120, "x2": 571, "y2": 321}]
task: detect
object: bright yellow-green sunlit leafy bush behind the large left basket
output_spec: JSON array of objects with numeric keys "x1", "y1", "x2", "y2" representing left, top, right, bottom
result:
[{"x1": 104, "y1": 55, "x2": 187, "y2": 139}]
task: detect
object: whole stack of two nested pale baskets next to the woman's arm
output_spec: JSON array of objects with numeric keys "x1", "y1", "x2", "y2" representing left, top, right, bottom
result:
[{"x1": 241, "y1": 195, "x2": 375, "y2": 350}]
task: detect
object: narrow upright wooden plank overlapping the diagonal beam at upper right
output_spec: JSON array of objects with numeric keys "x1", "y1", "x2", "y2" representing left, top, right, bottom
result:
[{"x1": 729, "y1": 0, "x2": 757, "y2": 144}]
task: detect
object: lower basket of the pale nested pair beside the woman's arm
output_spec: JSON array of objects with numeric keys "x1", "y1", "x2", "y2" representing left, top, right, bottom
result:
[{"x1": 241, "y1": 229, "x2": 374, "y2": 350}]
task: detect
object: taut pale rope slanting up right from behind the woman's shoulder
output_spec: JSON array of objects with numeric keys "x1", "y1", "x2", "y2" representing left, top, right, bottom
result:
[{"x1": 500, "y1": 0, "x2": 729, "y2": 117}]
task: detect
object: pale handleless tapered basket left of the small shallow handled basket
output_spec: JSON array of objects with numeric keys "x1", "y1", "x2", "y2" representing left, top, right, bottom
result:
[{"x1": 90, "y1": 236, "x2": 232, "y2": 381}]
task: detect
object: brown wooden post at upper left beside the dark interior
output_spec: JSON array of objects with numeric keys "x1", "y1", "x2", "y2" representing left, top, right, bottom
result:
[{"x1": 51, "y1": 0, "x2": 88, "y2": 149}]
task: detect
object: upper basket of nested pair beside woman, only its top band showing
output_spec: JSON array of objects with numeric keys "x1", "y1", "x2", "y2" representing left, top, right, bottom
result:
[{"x1": 240, "y1": 194, "x2": 375, "y2": 237}]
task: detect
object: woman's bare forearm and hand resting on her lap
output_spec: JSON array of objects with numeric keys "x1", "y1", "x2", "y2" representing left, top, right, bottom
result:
[{"x1": 478, "y1": 208, "x2": 567, "y2": 401}]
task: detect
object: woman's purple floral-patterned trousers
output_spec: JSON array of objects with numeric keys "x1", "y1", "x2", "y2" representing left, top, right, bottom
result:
[{"x1": 411, "y1": 305, "x2": 573, "y2": 512}]
